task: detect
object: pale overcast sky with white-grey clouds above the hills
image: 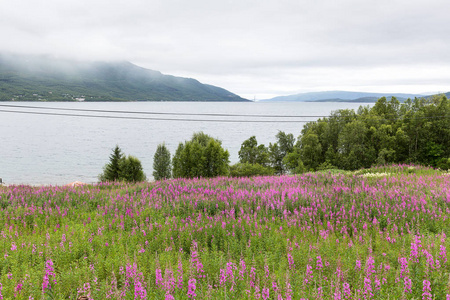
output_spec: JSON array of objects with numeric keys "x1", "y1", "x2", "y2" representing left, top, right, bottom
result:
[{"x1": 0, "y1": 0, "x2": 450, "y2": 99}]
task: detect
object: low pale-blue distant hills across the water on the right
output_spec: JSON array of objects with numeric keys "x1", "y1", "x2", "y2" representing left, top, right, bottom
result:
[{"x1": 260, "y1": 91, "x2": 427, "y2": 103}]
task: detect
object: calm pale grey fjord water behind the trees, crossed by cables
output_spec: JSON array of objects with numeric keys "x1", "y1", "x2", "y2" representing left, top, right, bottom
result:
[{"x1": 0, "y1": 102, "x2": 366, "y2": 185}]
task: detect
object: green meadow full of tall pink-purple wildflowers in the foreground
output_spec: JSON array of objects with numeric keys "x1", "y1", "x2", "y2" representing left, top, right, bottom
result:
[{"x1": 0, "y1": 165, "x2": 450, "y2": 300}]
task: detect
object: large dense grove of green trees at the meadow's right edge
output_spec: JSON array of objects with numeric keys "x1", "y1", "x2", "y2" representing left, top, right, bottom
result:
[{"x1": 296, "y1": 96, "x2": 450, "y2": 171}]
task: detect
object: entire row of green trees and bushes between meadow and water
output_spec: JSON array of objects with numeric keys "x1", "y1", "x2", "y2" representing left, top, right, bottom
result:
[{"x1": 100, "y1": 95, "x2": 450, "y2": 181}]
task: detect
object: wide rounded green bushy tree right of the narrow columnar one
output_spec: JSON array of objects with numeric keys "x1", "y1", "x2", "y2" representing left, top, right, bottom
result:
[{"x1": 172, "y1": 132, "x2": 230, "y2": 178}]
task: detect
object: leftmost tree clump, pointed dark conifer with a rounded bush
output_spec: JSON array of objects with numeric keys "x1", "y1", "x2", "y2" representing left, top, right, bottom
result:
[{"x1": 98, "y1": 145, "x2": 146, "y2": 182}]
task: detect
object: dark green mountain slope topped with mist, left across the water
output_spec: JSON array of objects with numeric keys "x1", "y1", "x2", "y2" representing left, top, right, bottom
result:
[{"x1": 0, "y1": 54, "x2": 249, "y2": 102}]
